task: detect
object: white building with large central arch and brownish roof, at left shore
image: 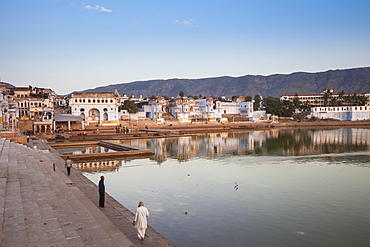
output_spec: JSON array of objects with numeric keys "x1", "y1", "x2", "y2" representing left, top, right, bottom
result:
[{"x1": 69, "y1": 93, "x2": 120, "y2": 125}]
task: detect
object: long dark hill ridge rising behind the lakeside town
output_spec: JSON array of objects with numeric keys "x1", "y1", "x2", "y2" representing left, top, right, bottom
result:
[{"x1": 75, "y1": 67, "x2": 370, "y2": 98}]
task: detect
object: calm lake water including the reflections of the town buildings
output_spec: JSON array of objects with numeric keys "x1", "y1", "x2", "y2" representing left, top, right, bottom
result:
[{"x1": 77, "y1": 129, "x2": 370, "y2": 247}]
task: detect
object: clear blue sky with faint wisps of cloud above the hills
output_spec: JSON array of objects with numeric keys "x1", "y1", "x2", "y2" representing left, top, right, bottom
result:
[{"x1": 0, "y1": 0, "x2": 370, "y2": 94}]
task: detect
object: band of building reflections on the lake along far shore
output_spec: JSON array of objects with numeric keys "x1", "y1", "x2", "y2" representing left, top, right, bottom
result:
[{"x1": 121, "y1": 128, "x2": 370, "y2": 163}]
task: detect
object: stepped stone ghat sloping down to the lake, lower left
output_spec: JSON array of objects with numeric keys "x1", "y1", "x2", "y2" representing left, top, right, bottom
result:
[{"x1": 0, "y1": 138, "x2": 174, "y2": 247}]
